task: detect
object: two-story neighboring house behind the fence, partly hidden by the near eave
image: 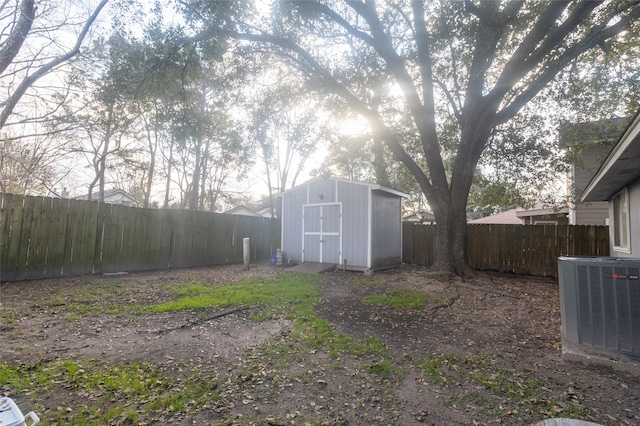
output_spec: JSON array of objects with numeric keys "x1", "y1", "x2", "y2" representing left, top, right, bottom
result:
[{"x1": 560, "y1": 118, "x2": 626, "y2": 225}]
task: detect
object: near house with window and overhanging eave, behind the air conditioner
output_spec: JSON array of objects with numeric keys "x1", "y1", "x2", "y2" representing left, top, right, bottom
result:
[{"x1": 581, "y1": 111, "x2": 640, "y2": 258}]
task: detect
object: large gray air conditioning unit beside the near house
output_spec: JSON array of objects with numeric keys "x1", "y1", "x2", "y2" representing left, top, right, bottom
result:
[{"x1": 558, "y1": 257, "x2": 640, "y2": 361}]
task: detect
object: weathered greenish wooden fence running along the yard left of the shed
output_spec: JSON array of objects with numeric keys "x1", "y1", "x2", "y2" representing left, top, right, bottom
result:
[{"x1": 0, "y1": 194, "x2": 280, "y2": 281}]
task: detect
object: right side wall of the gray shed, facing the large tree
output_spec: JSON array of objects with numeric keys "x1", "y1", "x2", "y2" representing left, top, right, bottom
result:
[{"x1": 371, "y1": 191, "x2": 402, "y2": 268}]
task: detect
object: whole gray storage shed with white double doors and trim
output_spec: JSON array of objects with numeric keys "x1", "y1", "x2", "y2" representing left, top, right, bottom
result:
[{"x1": 282, "y1": 178, "x2": 407, "y2": 271}]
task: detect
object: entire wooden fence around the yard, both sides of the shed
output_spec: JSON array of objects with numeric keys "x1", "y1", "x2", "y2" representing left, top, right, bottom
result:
[{"x1": 0, "y1": 194, "x2": 609, "y2": 281}]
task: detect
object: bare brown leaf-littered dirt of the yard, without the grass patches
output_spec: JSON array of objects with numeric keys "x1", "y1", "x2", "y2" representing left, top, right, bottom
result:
[{"x1": 0, "y1": 264, "x2": 640, "y2": 425}]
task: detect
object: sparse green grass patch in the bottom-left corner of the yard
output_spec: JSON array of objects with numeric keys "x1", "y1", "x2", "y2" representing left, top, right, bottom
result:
[{"x1": 0, "y1": 359, "x2": 219, "y2": 426}]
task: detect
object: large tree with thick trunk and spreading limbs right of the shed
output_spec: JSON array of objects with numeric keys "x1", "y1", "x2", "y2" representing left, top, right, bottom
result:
[{"x1": 186, "y1": 0, "x2": 640, "y2": 273}]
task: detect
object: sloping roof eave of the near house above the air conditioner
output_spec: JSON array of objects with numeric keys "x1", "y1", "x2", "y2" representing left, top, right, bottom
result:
[{"x1": 581, "y1": 111, "x2": 640, "y2": 202}]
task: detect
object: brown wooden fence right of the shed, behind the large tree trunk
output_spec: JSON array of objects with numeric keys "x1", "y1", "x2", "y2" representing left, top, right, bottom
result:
[{"x1": 403, "y1": 224, "x2": 609, "y2": 277}]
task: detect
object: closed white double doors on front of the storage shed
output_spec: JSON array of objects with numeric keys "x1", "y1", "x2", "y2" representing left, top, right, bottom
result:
[{"x1": 302, "y1": 204, "x2": 342, "y2": 264}]
